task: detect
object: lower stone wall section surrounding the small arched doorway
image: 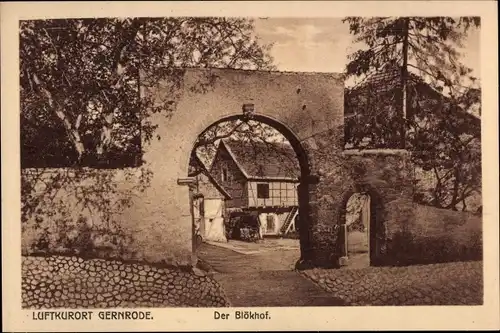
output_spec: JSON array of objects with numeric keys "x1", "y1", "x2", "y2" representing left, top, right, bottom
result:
[{"x1": 339, "y1": 150, "x2": 415, "y2": 265}]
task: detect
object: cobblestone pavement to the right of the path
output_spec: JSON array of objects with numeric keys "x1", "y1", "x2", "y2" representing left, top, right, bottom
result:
[{"x1": 302, "y1": 261, "x2": 483, "y2": 306}]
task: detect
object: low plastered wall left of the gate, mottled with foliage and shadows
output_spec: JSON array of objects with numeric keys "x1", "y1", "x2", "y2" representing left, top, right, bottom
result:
[{"x1": 21, "y1": 168, "x2": 148, "y2": 260}]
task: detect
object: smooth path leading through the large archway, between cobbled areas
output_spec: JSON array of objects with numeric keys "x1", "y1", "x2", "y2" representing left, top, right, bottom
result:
[{"x1": 199, "y1": 244, "x2": 344, "y2": 307}]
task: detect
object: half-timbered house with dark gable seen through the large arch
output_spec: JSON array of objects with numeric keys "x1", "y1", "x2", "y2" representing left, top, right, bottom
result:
[{"x1": 210, "y1": 140, "x2": 300, "y2": 235}]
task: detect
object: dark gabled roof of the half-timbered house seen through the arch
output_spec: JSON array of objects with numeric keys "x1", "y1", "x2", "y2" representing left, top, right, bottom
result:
[{"x1": 219, "y1": 139, "x2": 300, "y2": 180}]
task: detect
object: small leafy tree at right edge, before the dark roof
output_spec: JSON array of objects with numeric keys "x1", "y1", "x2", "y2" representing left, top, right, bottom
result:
[{"x1": 409, "y1": 84, "x2": 482, "y2": 210}]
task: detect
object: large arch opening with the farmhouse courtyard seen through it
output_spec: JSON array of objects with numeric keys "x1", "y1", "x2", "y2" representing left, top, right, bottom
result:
[{"x1": 187, "y1": 115, "x2": 309, "y2": 269}]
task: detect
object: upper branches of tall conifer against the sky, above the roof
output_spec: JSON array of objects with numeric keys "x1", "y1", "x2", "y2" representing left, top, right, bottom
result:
[{"x1": 344, "y1": 17, "x2": 480, "y2": 92}]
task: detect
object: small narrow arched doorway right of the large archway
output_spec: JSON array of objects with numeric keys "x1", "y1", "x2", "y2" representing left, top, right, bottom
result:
[{"x1": 342, "y1": 192, "x2": 375, "y2": 268}]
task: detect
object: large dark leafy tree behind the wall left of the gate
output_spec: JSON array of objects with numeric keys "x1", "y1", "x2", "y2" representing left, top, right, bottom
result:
[{"x1": 20, "y1": 17, "x2": 272, "y2": 165}]
